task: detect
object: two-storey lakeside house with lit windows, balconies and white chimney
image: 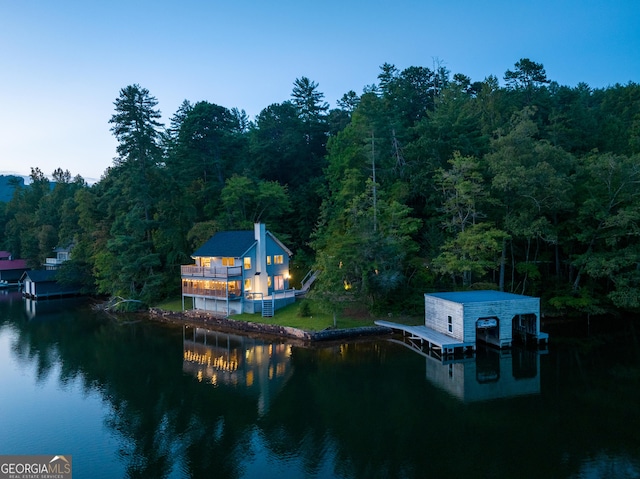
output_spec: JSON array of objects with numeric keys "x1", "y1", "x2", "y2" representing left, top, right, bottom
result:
[{"x1": 181, "y1": 223, "x2": 295, "y2": 316}]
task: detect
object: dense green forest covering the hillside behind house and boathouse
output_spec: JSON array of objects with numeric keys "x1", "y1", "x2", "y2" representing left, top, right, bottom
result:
[{"x1": 0, "y1": 58, "x2": 640, "y2": 315}]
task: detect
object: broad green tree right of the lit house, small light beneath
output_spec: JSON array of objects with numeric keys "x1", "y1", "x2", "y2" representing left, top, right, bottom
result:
[{"x1": 313, "y1": 176, "x2": 420, "y2": 308}]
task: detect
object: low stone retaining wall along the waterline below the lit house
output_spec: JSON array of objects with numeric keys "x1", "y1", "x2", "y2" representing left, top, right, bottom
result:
[{"x1": 148, "y1": 308, "x2": 392, "y2": 343}]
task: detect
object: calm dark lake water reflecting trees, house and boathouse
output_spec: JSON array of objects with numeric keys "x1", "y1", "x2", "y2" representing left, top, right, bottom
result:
[{"x1": 0, "y1": 293, "x2": 640, "y2": 479}]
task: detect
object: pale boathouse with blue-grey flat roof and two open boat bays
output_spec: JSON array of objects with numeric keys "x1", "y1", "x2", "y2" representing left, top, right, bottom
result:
[{"x1": 424, "y1": 291, "x2": 549, "y2": 348}]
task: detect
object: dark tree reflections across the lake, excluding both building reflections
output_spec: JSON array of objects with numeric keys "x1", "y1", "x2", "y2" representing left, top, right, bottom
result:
[{"x1": 5, "y1": 306, "x2": 640, "y2": 478}]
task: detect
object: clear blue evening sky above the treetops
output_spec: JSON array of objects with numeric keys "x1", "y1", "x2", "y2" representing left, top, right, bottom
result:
[{"x1": 0, "y1": 0, "x2": 640, "y2": 182}]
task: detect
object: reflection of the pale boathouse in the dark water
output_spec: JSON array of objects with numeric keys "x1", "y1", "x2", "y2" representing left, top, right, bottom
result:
[{"x1": 392, "y1": 340, "x2": 546, "y2": 402}]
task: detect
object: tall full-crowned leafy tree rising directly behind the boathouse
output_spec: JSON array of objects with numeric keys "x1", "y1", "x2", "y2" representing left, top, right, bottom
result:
[{"x1": 485, "y1": 107, "x2": 574, "y2": 293}]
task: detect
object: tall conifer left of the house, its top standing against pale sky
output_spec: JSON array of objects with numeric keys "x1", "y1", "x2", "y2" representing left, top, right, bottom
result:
[{"x1": 95, "y1": 85, "x2": 163, "y2": 302}]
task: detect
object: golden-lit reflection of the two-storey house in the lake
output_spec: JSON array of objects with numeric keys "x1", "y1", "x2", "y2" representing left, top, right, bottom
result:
[{"x1": 182, "y1": 326, "x2": 292, "y2": 414}]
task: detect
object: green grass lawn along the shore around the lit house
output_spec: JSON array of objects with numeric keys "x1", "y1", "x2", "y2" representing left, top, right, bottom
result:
[{"x1": 149, "y1": 298, "x2": 424, "y2": 331}]
